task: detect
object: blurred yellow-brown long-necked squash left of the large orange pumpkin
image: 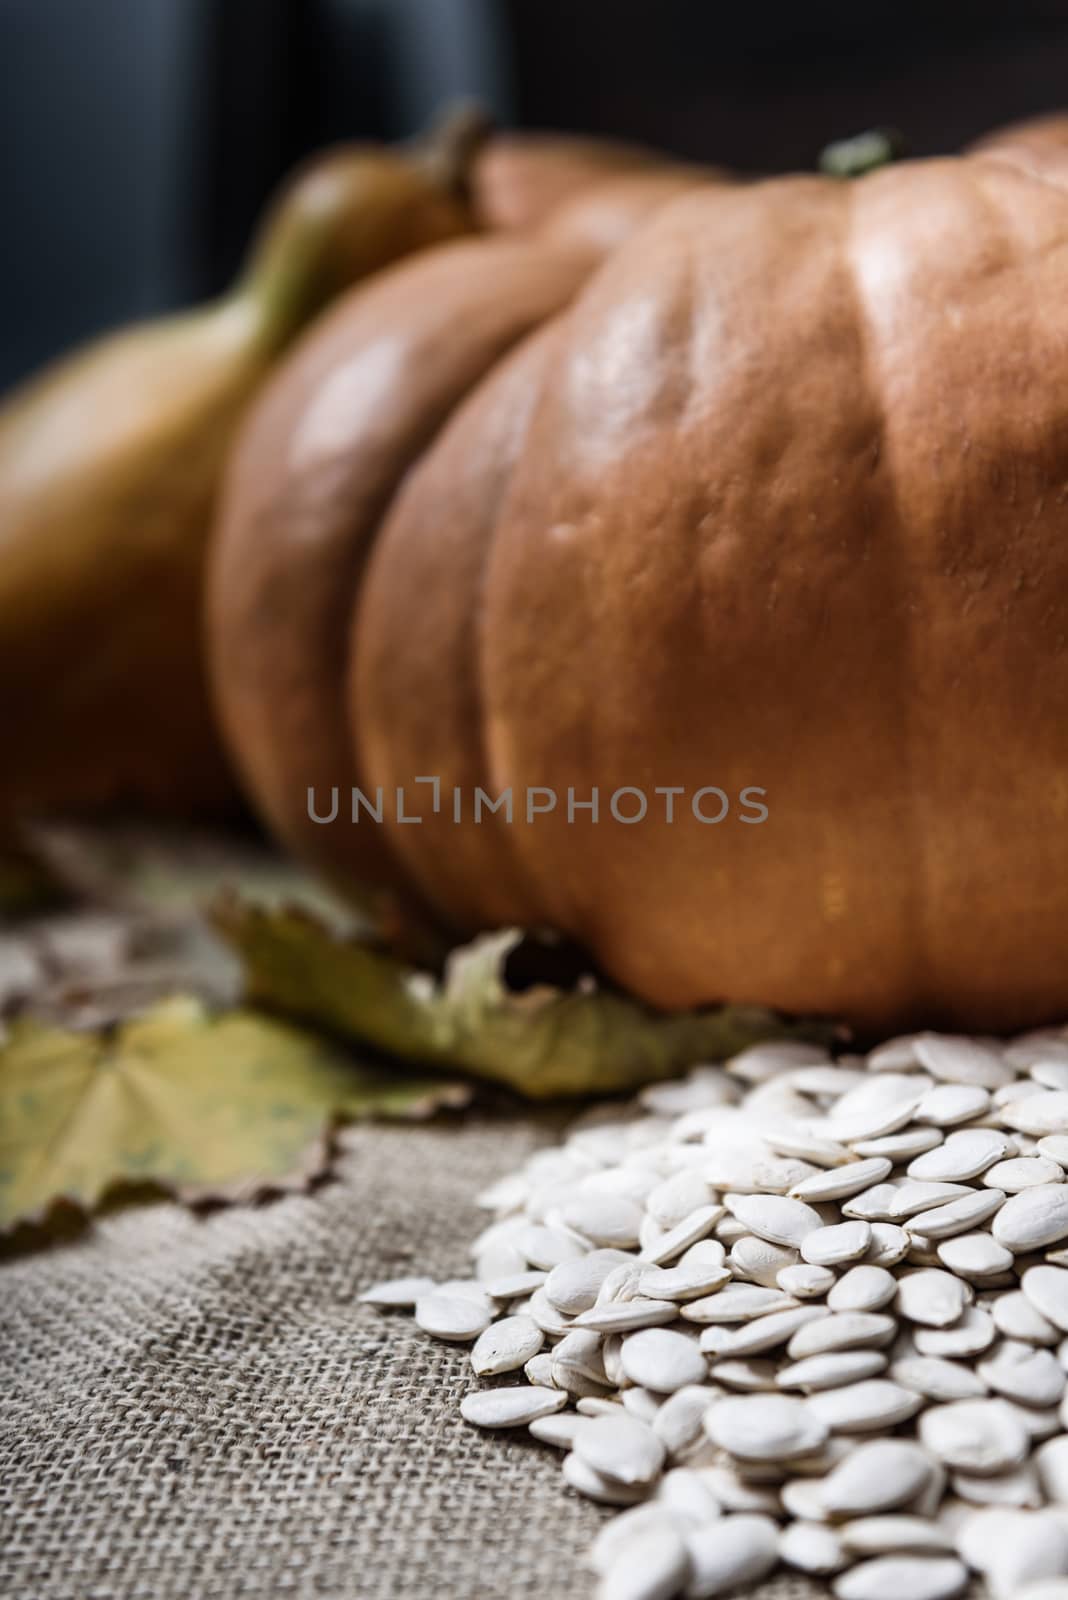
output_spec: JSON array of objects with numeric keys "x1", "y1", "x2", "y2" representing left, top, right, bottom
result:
[{"x1": 0, "y1": 115, "x2": 478, "y2": 822}]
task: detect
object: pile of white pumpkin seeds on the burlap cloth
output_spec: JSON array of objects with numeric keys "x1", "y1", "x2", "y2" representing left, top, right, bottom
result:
[{"x1": 363, "y1": 1029, "x2": 1068, "y2": 1600}]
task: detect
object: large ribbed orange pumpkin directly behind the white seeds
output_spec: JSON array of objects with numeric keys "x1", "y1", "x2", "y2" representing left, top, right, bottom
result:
[{"x1": 209, "y1": 147, "x2": 1068, "y2": 1030}]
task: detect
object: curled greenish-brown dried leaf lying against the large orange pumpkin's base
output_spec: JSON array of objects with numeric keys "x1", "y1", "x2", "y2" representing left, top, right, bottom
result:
[{"x1": 213, "y1": 896, "x2": 831, "y2": 1099}]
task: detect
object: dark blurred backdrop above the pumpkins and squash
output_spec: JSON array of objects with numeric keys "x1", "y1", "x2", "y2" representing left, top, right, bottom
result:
[{"x1": 0, "y1": 0, "x2": 1068, "y2": 387}]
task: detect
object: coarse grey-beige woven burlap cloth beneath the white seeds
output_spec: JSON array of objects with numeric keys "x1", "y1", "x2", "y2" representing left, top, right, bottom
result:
[{"x1": 0, "y1": 1117, "x2": 815, "y2": 1600}]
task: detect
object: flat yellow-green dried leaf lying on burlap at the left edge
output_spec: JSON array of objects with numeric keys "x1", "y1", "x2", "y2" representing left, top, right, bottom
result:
[{"x1": 0, "y1": 998, "x2": 468, "y2": 1232}]
